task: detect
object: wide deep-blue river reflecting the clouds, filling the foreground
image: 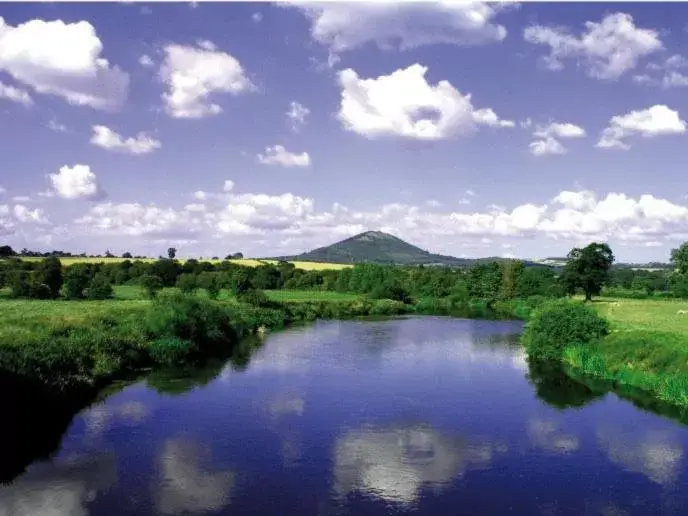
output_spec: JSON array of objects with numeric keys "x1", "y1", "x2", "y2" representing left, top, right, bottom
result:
[{"x1": 0, "y1": 317, "x2": 688, "y2": 516}]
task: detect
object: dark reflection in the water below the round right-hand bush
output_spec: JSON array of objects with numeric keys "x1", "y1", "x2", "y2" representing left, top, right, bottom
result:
[{"x1": 528, "y1": 358, "x2": 607, "y2": 408}]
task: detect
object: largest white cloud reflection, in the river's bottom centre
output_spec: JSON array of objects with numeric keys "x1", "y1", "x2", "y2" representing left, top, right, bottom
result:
[{"x1": 334, "y1": 425, "x2": 495, "y2": 504}]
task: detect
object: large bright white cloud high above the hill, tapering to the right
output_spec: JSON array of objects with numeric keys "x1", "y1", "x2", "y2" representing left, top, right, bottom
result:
[{"x1": 338, "y1": 64, "x2": 513, "y2": 140}]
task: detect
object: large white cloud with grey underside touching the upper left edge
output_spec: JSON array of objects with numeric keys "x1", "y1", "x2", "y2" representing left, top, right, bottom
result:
[{"x1": 0, "y1": 17, "x2": 129, "y2": 110}]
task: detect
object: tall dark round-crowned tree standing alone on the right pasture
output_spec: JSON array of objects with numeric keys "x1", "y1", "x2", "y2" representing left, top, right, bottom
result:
[{"x1": 561, "y1": 242, "x2": 614, "y2": 301}]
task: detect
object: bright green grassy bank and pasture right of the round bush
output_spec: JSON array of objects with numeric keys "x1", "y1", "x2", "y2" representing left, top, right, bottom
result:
[{"x1": 552, "y1": 299, "x2": 688, "y2": 407}]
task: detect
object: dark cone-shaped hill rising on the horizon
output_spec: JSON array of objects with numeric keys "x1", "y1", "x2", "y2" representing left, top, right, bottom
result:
[{"x1": 272, "y1": 231, "x2": 548, "y2": 267}]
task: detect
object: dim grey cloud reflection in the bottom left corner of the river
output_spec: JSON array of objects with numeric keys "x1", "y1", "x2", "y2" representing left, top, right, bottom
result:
[{"x1": 0, "y1": 454, "x2": 117, "y2": 516}]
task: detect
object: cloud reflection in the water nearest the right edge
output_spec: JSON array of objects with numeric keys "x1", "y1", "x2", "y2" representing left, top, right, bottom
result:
[{"x1": 596, "y1": 424, "x2": 683, "y2": 485}]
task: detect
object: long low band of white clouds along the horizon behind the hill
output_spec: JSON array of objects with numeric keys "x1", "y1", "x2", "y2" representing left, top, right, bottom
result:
[{"x1": 67, "y1": 179, "x2": 688, "y2": 254}]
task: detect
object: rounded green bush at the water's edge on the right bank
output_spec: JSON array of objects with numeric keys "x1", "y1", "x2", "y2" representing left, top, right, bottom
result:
[{"x1": 522, "y1": 299, "x2": 609, "y2": 360}]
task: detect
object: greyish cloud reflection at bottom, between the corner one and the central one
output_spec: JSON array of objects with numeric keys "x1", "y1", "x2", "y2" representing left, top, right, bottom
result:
[{"x1": 154, "y1": 438, "x2": 235, "y2": 514}]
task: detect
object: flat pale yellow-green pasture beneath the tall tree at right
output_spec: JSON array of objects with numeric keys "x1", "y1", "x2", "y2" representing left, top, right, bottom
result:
[{"x1": 593, "y1": 299, "x2": 688, "y2": 334}]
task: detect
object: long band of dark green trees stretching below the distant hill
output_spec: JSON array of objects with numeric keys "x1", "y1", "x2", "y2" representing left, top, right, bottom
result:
[{"x1": 0, "y1": 248, "x2": 688, "y2": 302}]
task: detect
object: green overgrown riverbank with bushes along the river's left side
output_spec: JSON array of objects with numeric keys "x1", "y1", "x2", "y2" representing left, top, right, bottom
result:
[{"x1": 0, "y1": 292, "x2": 532, "y2": 392}]
